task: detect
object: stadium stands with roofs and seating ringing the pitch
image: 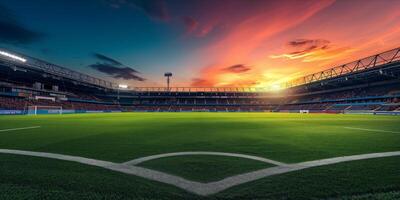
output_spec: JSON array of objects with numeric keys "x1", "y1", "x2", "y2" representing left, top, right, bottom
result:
[{"x1": 0, "y1": 48, "x2": 400, "y2": 114}]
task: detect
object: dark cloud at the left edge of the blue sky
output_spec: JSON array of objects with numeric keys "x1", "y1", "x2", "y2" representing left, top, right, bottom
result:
[{"x1": 0, "y1": 5, "x2": 43, "y2": 45}]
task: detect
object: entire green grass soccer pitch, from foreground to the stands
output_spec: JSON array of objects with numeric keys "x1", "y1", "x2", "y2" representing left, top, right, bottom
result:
[{"x1": 0, "y1": 113, "x2": 400, "y2": 199}]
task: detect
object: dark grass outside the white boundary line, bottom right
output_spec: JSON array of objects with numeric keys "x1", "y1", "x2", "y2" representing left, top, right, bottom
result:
[{"x1": 215, "y1": 157, "x2": 400, "y2": 200}]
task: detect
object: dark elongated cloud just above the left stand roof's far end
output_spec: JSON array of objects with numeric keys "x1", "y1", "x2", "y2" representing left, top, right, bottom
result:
[{"x1": 88, "y1": 53, "x2": 146, "y2": 81}]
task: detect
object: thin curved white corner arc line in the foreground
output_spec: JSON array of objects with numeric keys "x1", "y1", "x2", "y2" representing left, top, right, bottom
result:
[{"x1": 123, "y1": 151, "x2": 287, "y2": 166}]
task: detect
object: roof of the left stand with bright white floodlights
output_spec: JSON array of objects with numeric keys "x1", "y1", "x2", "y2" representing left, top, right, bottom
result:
[{"x1": 0, "y1": 49, "x2": 118, "y2": 89}]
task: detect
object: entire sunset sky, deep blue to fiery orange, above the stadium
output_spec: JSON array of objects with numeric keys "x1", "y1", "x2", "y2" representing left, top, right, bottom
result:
[{"x1": 0, "y1": 0, "x2": 400, "y2": 88}]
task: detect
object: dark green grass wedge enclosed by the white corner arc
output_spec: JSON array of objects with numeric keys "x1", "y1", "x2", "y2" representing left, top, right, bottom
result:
[{"x1": 139, "y1": 155, "x2": 274, "y2": 183}]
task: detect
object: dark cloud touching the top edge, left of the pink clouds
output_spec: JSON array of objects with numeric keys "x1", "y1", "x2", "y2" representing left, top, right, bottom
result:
[{"x1": 107, "y1": 0, "x2": 170, "y2": 21}]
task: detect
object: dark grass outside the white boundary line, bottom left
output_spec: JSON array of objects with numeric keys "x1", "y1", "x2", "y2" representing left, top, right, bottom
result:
[{"x1": 0, "y1": 154, "x2": 196, "y2": 200}]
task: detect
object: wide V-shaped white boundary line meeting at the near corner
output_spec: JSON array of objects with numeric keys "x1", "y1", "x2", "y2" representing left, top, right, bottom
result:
[{"x1": 0, "y1": 149, "x2": 400, "y2": 196}]
